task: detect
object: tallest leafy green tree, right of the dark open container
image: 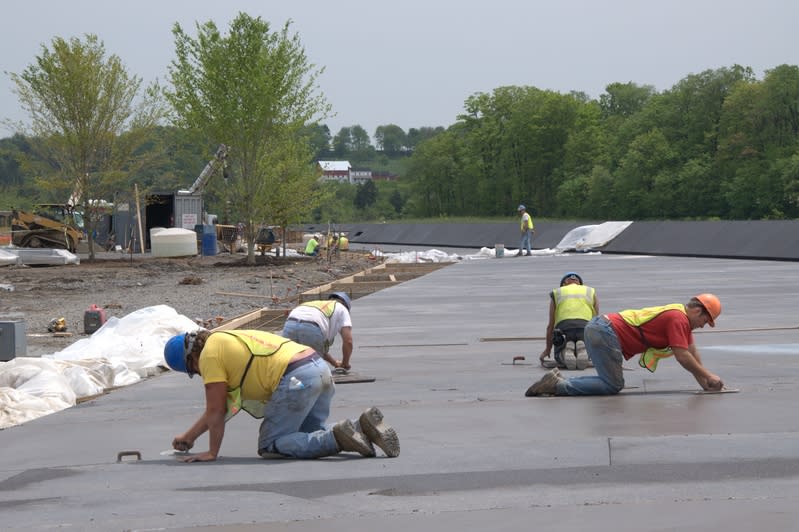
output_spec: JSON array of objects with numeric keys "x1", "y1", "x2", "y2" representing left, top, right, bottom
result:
[{"x1": 167, "y1": 13, "x2": 330, "y2": 264}]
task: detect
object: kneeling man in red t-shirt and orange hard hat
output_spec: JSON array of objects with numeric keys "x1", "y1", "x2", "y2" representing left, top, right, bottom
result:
[{"x1": 525, "y1": 294, "x2": 724, "y2": 397}]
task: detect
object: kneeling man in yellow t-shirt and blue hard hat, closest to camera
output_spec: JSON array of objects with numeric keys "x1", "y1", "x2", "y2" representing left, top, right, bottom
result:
[{"x1": 164, "y1": 329, "x2": 399, "y2": 462}]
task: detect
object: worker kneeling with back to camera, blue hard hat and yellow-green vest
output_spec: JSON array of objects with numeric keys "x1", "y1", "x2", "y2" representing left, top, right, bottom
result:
[{"x1": 538, "y1": 272, "x2": 599, "y2": 370}]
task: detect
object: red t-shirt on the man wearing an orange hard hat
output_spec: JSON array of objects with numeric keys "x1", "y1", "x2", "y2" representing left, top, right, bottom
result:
[{"x1": 607, "y1": 310, "x2": 694, "y2": 360}]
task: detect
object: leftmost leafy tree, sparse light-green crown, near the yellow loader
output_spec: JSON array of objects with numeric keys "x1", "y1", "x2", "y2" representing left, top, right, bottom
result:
[{"x1": 10, "y1": 35, "x2": 163, "y2": 260}]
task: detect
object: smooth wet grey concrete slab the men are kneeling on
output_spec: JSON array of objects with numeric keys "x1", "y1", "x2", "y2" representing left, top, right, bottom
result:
[{"x1": 0, "y1": 254, "x2": 799, "y2": 532}]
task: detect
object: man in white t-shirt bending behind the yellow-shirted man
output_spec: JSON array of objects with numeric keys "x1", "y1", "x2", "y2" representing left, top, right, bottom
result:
[{"x1": 281, "y1": 292, "x2": 352, "y2": 371}]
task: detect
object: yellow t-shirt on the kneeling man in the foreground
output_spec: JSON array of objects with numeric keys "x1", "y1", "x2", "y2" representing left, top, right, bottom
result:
[{"x1": 200, "y1": 331, "x2": 308, "y2": 401}]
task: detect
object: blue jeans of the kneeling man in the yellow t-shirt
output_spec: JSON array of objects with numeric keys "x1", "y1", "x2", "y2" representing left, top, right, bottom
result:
[{"x1": 258, "y1": 358, "x2": 338, "y2": 458}]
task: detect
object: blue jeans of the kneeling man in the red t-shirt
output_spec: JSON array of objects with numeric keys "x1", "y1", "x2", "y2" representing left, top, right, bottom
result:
[{"x1": 556, "y1": 316, "x2": 624, "y2": 395}]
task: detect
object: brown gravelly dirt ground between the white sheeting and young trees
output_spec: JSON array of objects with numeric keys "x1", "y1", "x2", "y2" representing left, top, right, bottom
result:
[{"x1": 0, "y1": 253, "x2": 379, "y2": 356}]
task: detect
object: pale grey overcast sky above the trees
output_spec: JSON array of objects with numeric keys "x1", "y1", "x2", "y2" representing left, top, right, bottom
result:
[{"x1": 0, "y1": 0, "x2": 799, "y2": 137}]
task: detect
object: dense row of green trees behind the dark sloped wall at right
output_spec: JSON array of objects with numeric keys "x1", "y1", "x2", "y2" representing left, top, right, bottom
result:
[{"x1": 406, "y1": 65, "x2": 799, "y2": 220}]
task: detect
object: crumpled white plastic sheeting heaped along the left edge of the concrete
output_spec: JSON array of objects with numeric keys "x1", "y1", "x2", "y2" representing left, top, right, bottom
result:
[{"x1": 0, "y1": 305, "x2": 198, "y2": 429}]
